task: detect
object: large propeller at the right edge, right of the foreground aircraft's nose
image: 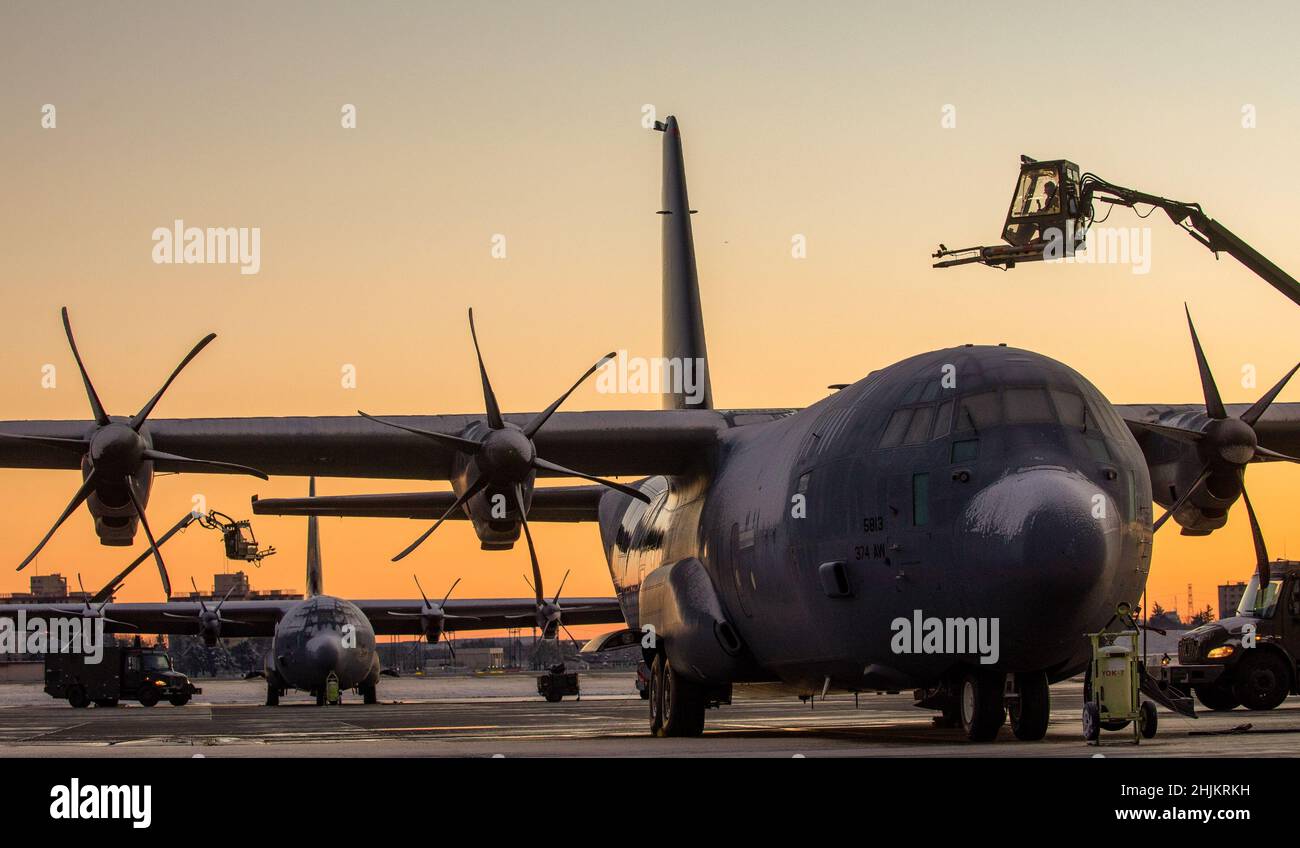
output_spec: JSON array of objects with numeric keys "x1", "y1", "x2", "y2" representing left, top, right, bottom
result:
[{"x1": 1141, "y1": 304, "x2": 1300, "y2": 533}]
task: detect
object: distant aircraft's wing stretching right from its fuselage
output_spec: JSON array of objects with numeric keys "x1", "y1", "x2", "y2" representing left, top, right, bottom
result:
[{"x1": 354, "y1": 598, "x2": 623, "y2": 636}]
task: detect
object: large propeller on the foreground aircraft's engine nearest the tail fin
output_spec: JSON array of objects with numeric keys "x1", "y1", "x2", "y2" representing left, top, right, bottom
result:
[{"x1": 358, "y1": 310, "x2": 650, "y2": 562}]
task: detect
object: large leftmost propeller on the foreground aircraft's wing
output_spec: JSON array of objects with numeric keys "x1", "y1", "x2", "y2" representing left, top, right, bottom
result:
[{"x1": 0, "y1": 307, "x2": 267, "y2": 580}]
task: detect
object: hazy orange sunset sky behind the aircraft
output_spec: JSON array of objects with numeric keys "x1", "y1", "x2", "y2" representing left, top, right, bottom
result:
[{"x1": 0, "y1": 1, "x2": 1300, "y2": 632}]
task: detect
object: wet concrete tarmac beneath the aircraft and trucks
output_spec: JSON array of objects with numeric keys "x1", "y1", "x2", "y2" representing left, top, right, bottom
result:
[{"x1": 0, "y1": 672, "x2": 1300, "y2": 757}]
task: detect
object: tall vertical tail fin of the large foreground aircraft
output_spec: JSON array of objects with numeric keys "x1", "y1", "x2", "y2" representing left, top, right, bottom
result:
[{"x1": 655, "y1": 114, "x2": 714, "y2": 410}]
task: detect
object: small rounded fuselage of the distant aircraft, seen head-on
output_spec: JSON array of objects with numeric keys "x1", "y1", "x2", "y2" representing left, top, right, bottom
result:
[{"x1": 267, "y1": 594, "x2": 380, "y2": 692}]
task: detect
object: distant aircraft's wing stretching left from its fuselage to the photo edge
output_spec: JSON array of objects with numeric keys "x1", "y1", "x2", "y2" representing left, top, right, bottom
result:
[{"x1": 0, "y1": 600, "x2": 299, "y2": 639}]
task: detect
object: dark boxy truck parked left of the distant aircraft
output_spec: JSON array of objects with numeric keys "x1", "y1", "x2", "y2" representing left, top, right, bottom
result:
[{"x1": 46, "y1": 645, "x2": 203, "y2": 709}]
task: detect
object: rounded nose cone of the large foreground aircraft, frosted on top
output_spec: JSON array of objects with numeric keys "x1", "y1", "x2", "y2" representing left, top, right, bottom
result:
[{"x1": 956, "y1": 467, "x2": 1118, "y2": 667}]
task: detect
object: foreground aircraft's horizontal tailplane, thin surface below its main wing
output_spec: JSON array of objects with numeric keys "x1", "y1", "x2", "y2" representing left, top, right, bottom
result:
[{"x1": 252, "y1": 485, "x2": 606, "y2": 522}]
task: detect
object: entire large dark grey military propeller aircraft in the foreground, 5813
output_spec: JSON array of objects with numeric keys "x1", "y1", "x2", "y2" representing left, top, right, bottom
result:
[{"x1": 0, "y1": 117, "x2": 1300, "y2": 740}]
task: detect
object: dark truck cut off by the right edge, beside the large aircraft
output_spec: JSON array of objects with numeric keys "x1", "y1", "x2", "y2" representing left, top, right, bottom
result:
[{"x1": 1157, "y1": 561, "x2": 1300, "y2": 710}]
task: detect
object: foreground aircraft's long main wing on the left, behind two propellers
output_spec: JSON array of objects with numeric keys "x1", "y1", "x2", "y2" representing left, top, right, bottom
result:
[{"x1": 0, "y1": 410, "x2": 788, "y2": 480}]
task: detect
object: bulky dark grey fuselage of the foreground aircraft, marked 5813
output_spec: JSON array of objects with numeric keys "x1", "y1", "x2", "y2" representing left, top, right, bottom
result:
[{"x1": 601, "y1": 346, "x2": 1152, "y2": 691}]
